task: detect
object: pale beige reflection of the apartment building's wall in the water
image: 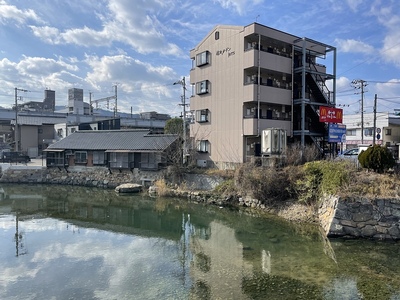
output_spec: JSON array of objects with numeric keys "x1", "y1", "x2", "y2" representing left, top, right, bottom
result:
[{"x1": 190, "y1": 222, "x2": 253, "y2": 299}]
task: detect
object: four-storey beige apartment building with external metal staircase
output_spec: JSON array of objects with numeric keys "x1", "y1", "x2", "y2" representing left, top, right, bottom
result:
[{"x1": 190, "y1": 23, "x2": 336, "y2": 168}]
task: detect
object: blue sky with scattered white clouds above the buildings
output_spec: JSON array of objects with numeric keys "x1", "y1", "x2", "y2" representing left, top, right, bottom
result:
[{"x1": 0, "y1": 0, "x2": 400, "y2": 116}]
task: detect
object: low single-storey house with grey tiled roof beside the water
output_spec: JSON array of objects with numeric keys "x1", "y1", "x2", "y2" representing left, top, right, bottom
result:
[{"x1": 45, "y1": 129, "x2": 180, "y2": 170}]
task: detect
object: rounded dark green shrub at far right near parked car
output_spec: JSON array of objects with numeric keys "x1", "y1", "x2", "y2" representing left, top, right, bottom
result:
[{"x1": 358, "y1": 145, "x2": 396, "y2": 173}]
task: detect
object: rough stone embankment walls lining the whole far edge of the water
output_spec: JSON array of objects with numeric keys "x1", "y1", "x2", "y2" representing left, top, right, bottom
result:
[{"x1": 0, "y1": 166, "x2": 400, "y2": 240}]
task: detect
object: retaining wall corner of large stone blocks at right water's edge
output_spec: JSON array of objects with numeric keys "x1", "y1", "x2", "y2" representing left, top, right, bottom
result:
[{"x1": 319, "y1": 196, "x2": 400, "y2": 240}]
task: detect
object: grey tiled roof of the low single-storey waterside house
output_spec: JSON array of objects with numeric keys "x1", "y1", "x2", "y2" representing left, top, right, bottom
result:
[{"x1": 47, "y1": 130, "x2": 178, "y2": 151}]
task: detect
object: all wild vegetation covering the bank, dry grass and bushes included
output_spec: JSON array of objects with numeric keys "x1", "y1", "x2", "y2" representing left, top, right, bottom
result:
[{"x1": 155, "y1": 143, "x2": 400, "y2": 221}]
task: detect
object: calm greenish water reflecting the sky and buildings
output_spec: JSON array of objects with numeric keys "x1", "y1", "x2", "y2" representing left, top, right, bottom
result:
[{"x1": 0, "y1": 185, "x2": 400, "y2": 300}]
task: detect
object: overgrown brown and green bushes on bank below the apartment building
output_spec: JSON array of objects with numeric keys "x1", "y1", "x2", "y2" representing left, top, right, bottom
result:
[{"x1": 214, "y1": 161, "x2": 357, "y2": 204}]
